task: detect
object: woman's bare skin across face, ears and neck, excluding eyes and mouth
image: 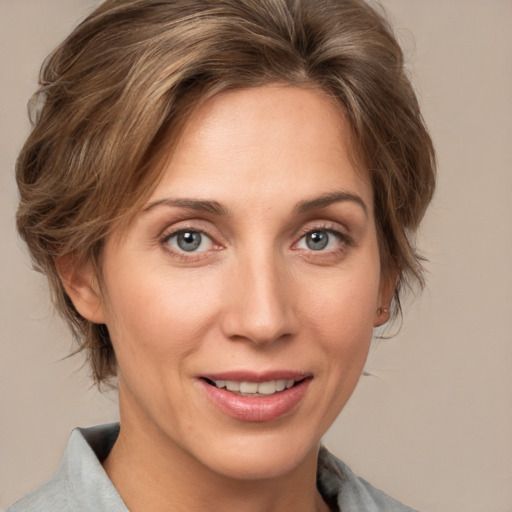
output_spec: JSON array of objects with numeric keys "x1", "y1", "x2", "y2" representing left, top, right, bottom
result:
[{"x1": 63, "y1": 85, "x2": 393, "y2": 512}]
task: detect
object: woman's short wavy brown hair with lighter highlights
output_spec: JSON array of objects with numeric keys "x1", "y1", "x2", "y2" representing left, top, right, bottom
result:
[{"x1": 16, "y1": 0, "x2": 435, "y2": 383}]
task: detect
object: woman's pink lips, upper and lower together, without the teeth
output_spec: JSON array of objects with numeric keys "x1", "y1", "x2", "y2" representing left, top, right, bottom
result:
[{"x1": 198, "y1": 372, "x2": 312, "y2": 422}]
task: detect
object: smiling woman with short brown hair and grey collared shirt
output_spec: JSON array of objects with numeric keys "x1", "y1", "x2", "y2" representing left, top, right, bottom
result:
[{"x1": 9, "y1": 0, "x2": 435, "y2": 512}]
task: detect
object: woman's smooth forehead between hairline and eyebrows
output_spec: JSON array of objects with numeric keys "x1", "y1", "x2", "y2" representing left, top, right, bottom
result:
[{"x1": 150, "y1": 85, "x2": 372, "y2": 211}]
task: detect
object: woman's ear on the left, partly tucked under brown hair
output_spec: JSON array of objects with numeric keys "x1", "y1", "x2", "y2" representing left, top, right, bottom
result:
[{"x1": 55, "y1": 255, "x2": 105, "y2": 324}]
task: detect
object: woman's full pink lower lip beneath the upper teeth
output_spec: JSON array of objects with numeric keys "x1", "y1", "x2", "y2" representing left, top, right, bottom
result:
[{"x1": 199, "y1": 378, "x2": 311, "y2": 422}]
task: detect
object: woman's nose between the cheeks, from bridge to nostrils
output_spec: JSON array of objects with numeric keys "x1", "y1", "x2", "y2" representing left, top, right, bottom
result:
[{"x1": 221, "y1": 249, "x2": 296, "y2": 347}]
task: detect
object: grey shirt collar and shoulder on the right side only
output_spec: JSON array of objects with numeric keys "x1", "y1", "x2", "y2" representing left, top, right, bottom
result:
[{"x1": 318, "y1": 448, "x2": 422, "y2": 512}]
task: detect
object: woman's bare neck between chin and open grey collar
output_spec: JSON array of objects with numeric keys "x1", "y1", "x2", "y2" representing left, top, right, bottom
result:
[{"x1": 103, "y1": 394, "x2": 329, "y2": 512}]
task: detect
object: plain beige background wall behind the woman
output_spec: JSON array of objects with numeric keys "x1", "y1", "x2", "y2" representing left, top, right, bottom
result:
[{"x1": 0, "y1": 0, "x2": 512, "y2": 512}]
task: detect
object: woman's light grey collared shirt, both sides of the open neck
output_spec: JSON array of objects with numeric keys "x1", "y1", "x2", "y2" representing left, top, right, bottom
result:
[{"x1": 6, "y1": 423, "x2": 415, "y2": 512}]
